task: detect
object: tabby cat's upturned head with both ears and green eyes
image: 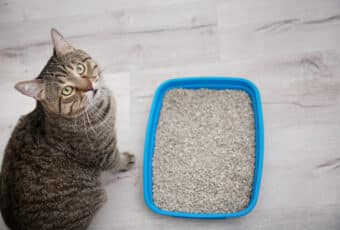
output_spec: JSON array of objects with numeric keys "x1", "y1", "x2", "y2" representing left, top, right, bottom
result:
[{"x1": 15, "y1": 29, "x2": 101, "y2": 116}]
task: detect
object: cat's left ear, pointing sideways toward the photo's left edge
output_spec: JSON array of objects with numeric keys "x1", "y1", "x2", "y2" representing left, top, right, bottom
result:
[{"x1": 15, "y1": 79, "x2": 45, "y2": 101}]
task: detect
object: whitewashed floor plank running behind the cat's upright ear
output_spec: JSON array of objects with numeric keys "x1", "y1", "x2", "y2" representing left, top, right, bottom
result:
[{"x1": 0, "y1": 26, "x2": 219, "y2": 80}]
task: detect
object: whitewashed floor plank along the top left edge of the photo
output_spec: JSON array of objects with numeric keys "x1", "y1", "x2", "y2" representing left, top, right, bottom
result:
[{"x1": 0, "y1": 0, "x2": 202, "y2": 23}]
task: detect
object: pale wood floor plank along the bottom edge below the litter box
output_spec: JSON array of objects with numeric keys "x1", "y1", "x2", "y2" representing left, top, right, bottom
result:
[{"x1": 90, "y1": 205, "x2": 340, "y2": 230}]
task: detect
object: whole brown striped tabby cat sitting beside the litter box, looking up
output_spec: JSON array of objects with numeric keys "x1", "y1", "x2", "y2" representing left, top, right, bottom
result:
[{"x1": 0, "y1": 29, "x2": 135, "y2": 230}]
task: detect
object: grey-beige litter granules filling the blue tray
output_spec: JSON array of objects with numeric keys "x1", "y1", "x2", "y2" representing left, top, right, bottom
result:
[{"x1": 152, "y1": 89, "x2": 255, "y2": 213}]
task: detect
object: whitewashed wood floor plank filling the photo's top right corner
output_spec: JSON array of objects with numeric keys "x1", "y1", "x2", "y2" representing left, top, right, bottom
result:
[{"x1": 218, "y1": 0, "x2": 340, "y2": 61}]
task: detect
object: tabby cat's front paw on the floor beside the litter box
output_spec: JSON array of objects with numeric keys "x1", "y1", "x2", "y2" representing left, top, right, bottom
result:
[{"x1": 103, "y1": 148, "x2": 135, "y2": 172}]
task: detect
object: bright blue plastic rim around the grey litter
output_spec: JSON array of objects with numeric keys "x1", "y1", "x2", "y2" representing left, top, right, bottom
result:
[{"x1": 143, "y1": 77, "x2": 264, "y2": 219}]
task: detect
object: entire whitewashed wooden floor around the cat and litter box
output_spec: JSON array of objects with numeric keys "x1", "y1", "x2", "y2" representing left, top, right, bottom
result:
[{"x1": 0, "y1": 0, "x2": 340, "y2": 230}]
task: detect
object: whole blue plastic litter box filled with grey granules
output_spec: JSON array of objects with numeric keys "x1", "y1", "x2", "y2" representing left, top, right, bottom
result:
[{"x1": 144, "y1": 78, "x2": 263, "y2": 218}]
